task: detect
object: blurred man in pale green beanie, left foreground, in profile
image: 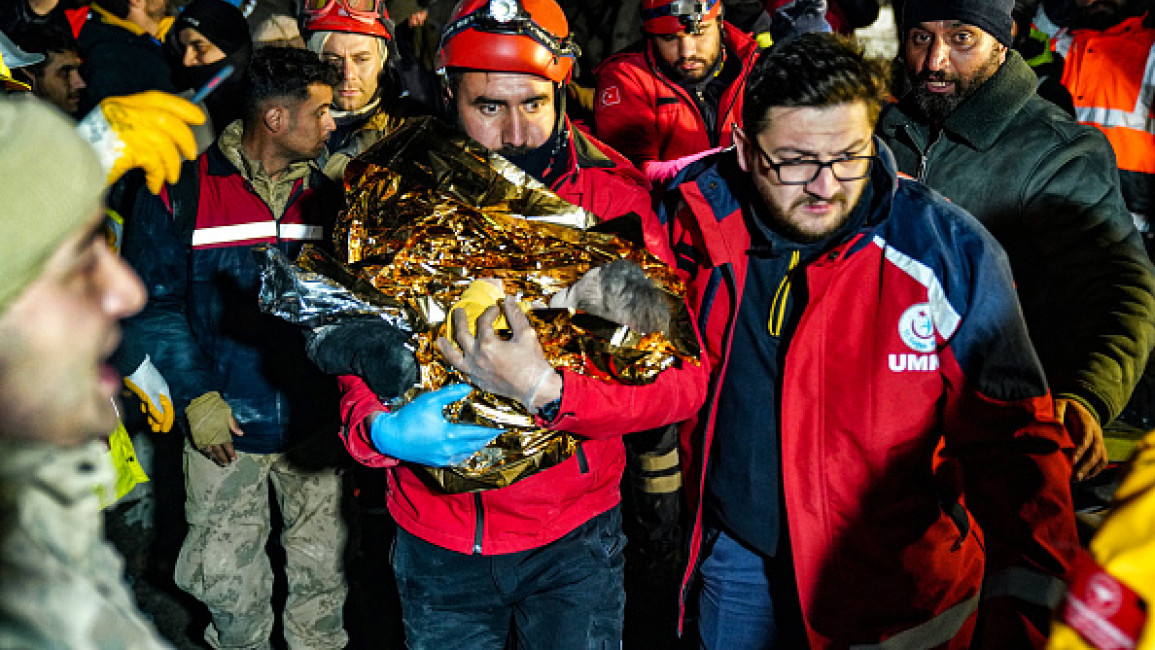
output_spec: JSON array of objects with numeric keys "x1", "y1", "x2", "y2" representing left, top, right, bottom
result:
[{"x1": 0, "y1": 98, "x2": 168, "y2": 650}]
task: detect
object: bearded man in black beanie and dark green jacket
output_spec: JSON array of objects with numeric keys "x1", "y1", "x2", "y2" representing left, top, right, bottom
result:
[{"x1": 878, "y1": 0, "x2": 1155, "y2": 479}]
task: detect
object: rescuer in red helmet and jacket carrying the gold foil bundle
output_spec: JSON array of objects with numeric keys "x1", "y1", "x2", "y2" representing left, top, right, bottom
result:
[{"x1": 341, "y1": 0, "x2": 708, "y2": 650}]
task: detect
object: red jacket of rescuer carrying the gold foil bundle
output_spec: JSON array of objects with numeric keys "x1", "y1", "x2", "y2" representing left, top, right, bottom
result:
[{"x1": 340, "y1": 125, "x2": 709, "y2": 555}]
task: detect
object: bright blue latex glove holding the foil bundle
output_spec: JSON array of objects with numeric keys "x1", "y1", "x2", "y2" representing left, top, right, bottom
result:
[{"x1": 370, "y1": 383, "x2": 501, "y2": 468}]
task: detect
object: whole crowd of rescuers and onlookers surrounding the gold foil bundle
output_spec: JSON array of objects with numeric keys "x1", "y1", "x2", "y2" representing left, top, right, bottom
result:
[{"x1": 0, "y1": 0, "x2": 1155, "y2": 650}]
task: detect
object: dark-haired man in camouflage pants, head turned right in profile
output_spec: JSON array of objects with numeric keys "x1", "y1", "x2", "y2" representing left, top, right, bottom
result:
[{"x1": 121, "y1": 47, "x2": 348, "y2": 648}]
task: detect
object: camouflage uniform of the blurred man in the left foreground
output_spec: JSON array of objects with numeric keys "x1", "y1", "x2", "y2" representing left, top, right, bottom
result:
[{"x1": 0, "y1": 440, "x2": 170, "y2": 650}]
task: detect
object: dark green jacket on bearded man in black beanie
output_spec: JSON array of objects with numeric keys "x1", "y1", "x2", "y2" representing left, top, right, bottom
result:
[{"x1": 878, "y1": 50, "x2": 1155, "y2": 424}]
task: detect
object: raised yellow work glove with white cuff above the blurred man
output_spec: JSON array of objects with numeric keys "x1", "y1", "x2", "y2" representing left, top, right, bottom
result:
[{"x1": 77, "y1": 90, "x2": 204, "y2": 194}]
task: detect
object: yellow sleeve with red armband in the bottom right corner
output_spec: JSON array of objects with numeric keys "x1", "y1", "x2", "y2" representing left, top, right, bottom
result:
[{"x1": 1046, "y1": 434, "x2": 1155, "y2": 650}]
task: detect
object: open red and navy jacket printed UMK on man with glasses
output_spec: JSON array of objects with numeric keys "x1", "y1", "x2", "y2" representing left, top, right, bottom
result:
[{"x1": 657, "y1": 142, "x2": 1078, "y2": 648}]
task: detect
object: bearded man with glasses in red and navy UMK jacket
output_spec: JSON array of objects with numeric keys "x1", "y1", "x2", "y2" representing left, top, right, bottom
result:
[{"x1": 657, "y1": 33, "x2": 1078, "y2": 650}]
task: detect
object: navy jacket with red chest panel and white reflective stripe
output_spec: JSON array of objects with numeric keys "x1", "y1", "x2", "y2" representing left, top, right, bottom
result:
[{"x1": 122, "y1": 138, "x2": 341, "y2": 454}]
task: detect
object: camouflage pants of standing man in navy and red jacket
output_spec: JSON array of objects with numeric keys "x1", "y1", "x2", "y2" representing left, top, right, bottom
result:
[{"x1": 176, "y1": 441, "x2": 349, "y2": 650}]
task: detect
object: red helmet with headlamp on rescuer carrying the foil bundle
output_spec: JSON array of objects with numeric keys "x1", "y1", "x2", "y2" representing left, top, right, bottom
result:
[{"x1": 439, "y1": 0, "x2": 581, "y2": 83}]
